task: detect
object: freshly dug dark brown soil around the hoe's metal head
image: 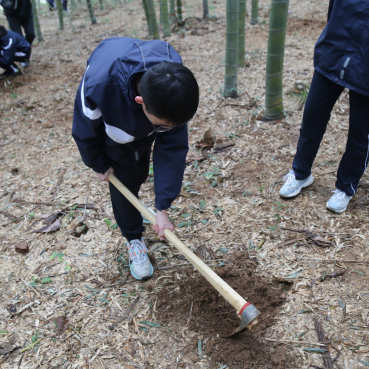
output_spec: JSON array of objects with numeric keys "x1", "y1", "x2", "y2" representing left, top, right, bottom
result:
[{"x1": 157, "y1": 252, "x2": 293, "y2": 369}]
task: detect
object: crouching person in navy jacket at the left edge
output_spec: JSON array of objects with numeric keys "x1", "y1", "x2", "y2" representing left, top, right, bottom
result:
[{"x1": 0, "y1": 25, "x2": 31, "y2": 79}]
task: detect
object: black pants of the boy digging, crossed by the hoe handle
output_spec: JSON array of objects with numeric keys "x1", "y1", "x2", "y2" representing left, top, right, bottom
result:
[{"x1": 106, "y1": 141, "x2": 154, "y2": 241}]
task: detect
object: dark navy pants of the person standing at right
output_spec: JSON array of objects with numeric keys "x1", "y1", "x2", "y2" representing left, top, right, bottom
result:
[{"x1": 292, "y1": 71, "x2": 369, "y2": 196}]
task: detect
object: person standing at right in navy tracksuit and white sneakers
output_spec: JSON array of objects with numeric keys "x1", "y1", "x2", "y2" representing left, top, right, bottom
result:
[{"x1": 279, "y1": 0, "x2": 369, "y2": 213}]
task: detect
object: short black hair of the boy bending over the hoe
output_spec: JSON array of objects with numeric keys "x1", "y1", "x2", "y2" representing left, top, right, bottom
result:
[{"x1": 140, "y1": 62, "x2": 199, "y2": 126}]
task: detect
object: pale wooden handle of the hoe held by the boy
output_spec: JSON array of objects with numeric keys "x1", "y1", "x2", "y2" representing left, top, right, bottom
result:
[{"x1": 108, "y1": 174, "x2": 249, "y2": 315}]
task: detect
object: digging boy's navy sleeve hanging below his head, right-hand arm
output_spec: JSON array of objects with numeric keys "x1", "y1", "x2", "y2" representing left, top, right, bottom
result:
[{"x1": 153, "y1": 124, "x2": 188, "y2": 211}]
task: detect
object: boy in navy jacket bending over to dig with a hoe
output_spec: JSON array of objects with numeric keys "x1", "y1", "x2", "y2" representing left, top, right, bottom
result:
[{"x1": 72, "y1": 37, "x2": 199, "y2": 279}]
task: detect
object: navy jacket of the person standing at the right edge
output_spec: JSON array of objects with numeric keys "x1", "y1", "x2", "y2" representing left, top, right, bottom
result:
[{"x1": 314, "y1": 0, "x2": 369, "y2": 96}]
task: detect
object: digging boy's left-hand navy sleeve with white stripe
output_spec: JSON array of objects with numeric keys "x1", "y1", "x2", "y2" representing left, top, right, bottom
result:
[{"x1": 72, "y1": 79, "x2": 110, "y2": 173}]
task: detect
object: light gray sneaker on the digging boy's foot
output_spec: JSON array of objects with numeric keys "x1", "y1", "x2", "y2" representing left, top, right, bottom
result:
[{"x1": 127, "y1": 237, "x2": 154, "y2": 279}]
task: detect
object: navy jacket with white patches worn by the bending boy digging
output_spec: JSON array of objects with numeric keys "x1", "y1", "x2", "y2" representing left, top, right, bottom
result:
[{"x1": 72, "y1": 37, "x2": 188, "y2": 210}]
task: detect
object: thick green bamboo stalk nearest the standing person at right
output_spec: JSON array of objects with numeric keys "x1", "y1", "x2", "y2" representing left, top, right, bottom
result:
[{"x1": 265, "y1": 0, "x2": 288, "y2": 120}]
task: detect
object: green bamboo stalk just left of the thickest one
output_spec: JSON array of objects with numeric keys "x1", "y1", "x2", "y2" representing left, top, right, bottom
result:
[{"x1": 224, "y1": 0, "x2": 239, "y2": 97}]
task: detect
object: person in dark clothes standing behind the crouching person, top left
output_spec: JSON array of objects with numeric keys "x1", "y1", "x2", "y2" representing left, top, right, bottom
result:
[{"x1": 3, "y1": 0, "x2": 36, "y2": 67}]
